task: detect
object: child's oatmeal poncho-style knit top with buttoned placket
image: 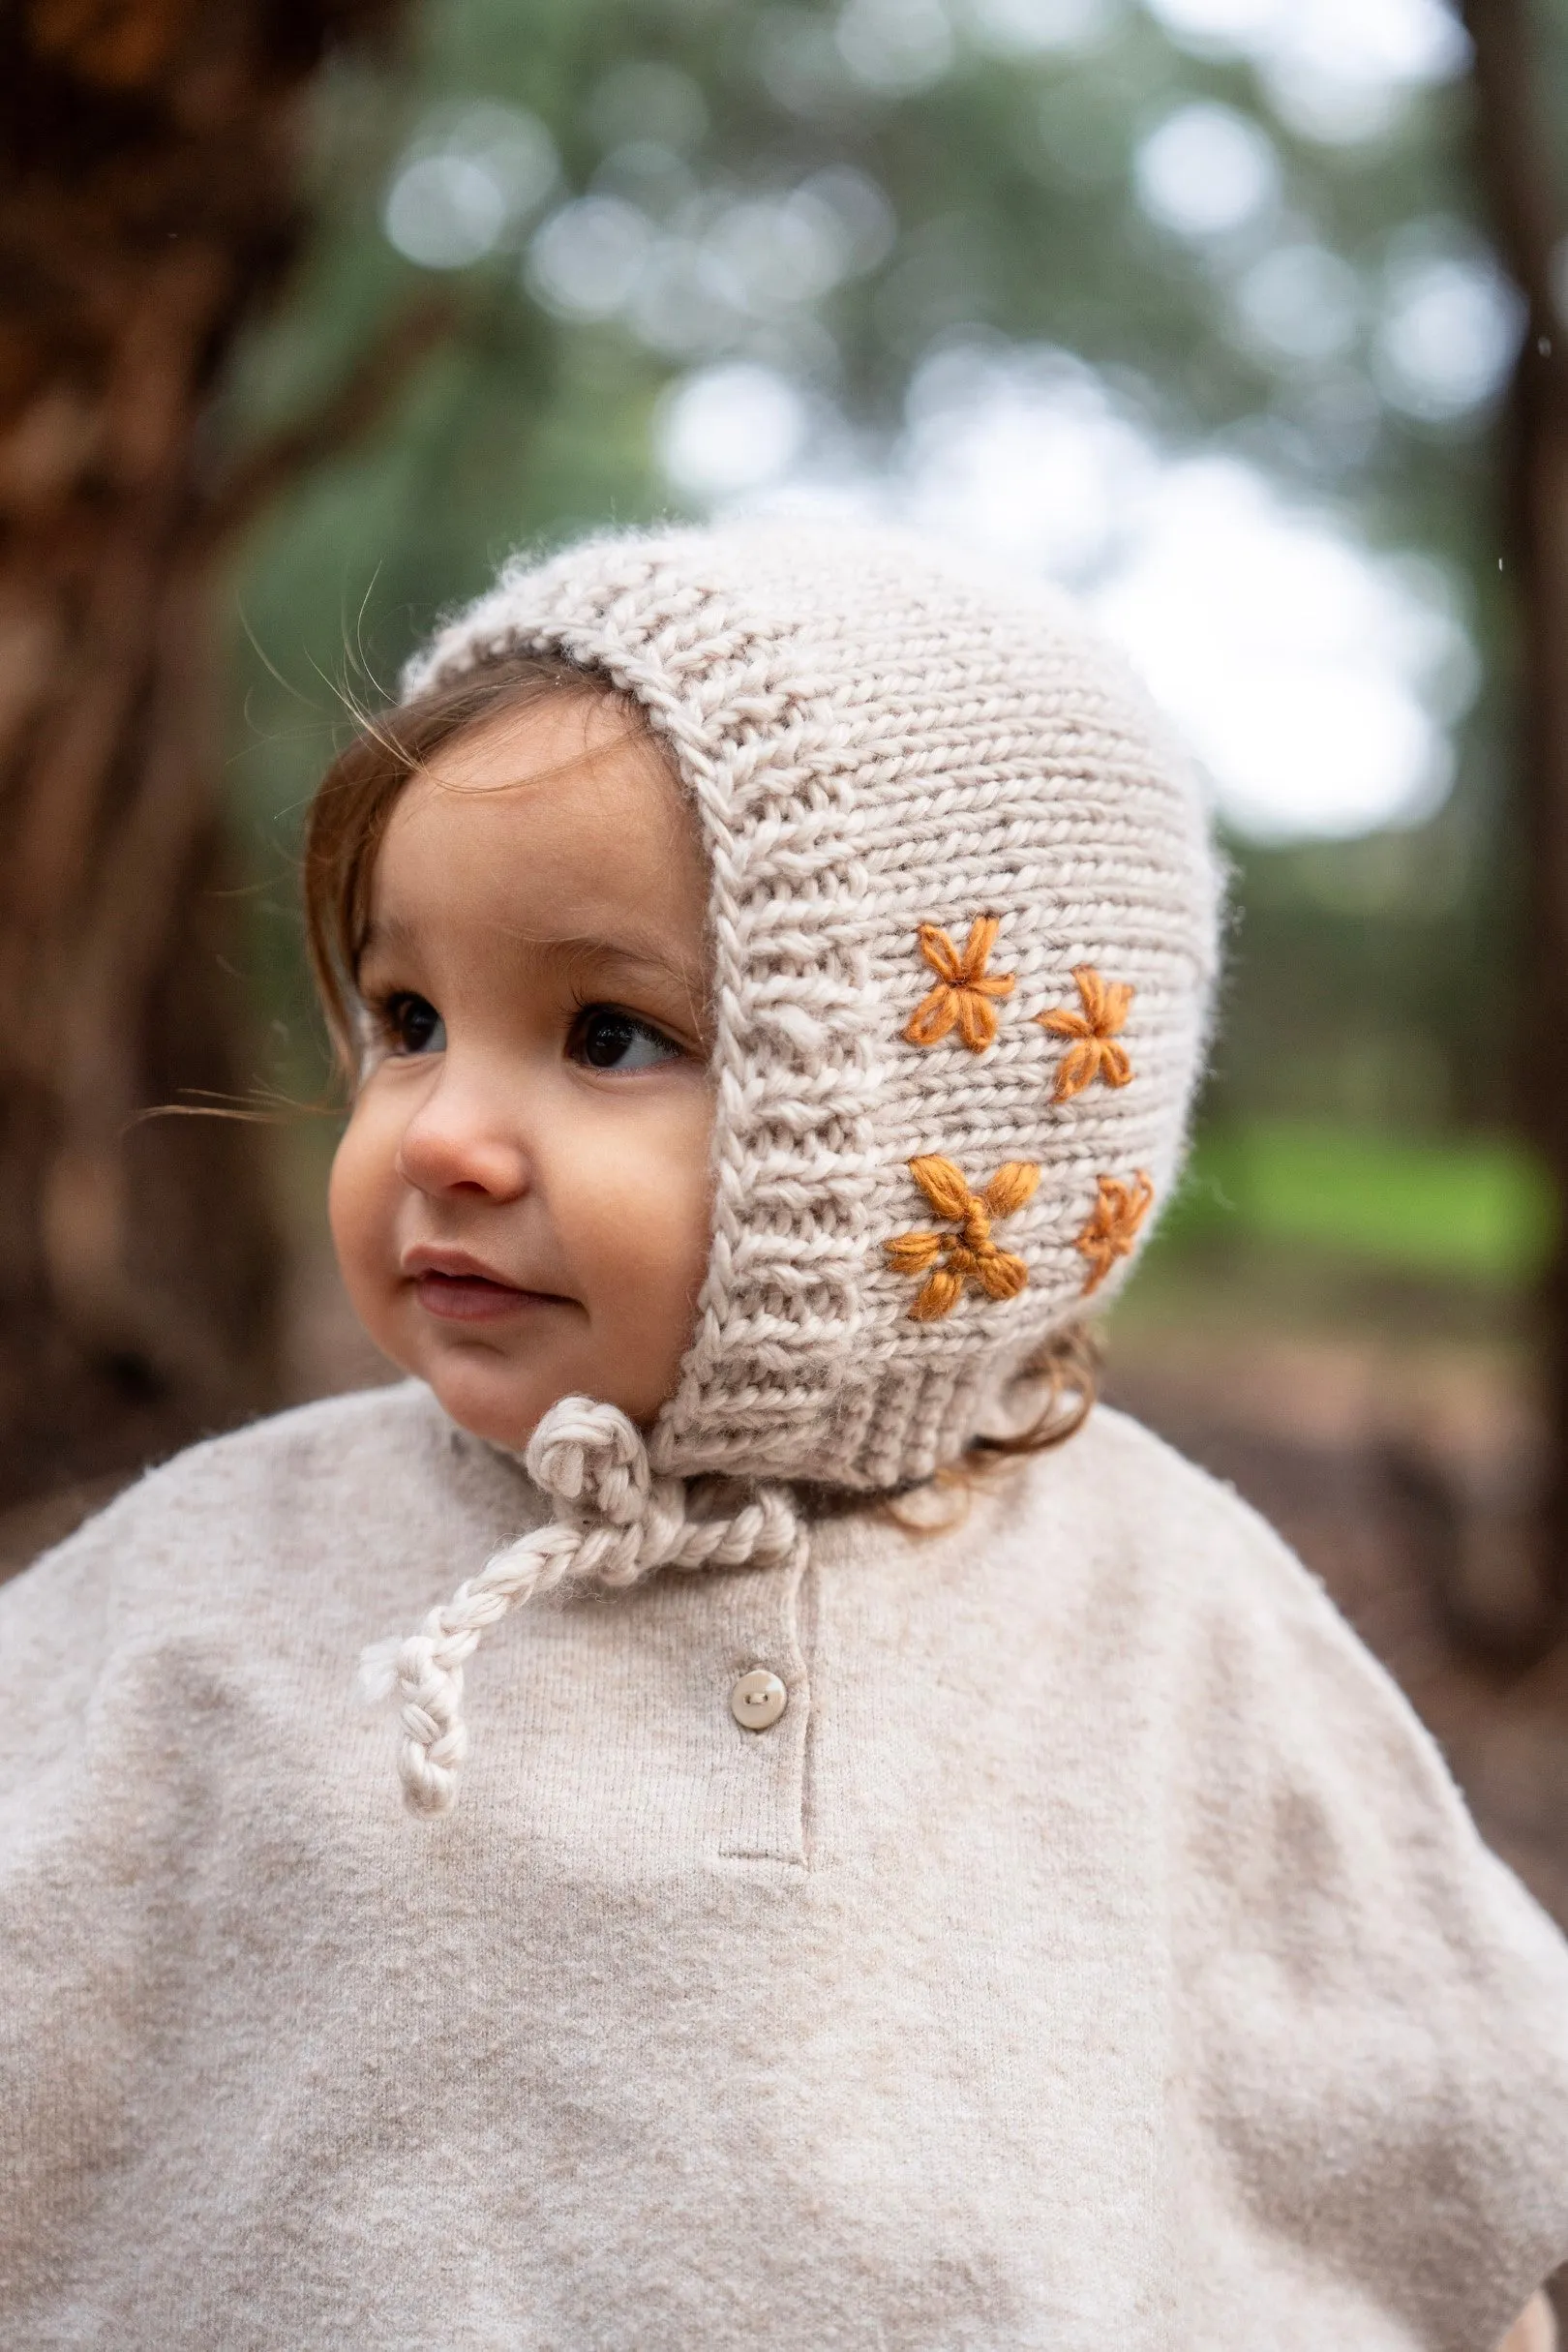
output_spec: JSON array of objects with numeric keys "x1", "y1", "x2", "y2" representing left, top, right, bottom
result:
[{"x1": 0, "y1": 1388, "x2": 1568, "y2": 2352}]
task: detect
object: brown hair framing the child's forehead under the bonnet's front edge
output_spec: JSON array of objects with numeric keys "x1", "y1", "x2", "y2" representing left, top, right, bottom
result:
[{"x1": 303, "y1": 654, "x2": 648, "y2": 1084}]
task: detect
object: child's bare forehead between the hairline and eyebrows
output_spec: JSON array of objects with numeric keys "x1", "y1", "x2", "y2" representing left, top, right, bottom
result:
[{"x1": 372, "y1": 694, "x2": 706, "y2": 931}]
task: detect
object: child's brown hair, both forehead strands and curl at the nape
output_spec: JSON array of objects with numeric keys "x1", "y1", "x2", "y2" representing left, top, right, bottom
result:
[{"x1": 303, "y1": 654, "x2": 1101, "y2": 1486}]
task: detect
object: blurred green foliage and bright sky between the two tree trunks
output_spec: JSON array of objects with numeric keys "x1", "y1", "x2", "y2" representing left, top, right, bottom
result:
[{"x1": 242, "y1": 0, "x2": 1552, "y2": 1334}]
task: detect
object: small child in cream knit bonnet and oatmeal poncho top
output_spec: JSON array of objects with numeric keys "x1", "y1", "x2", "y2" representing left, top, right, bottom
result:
[{"x1": 0, "y1": 525, "x2": 1568, "y2": 2352}]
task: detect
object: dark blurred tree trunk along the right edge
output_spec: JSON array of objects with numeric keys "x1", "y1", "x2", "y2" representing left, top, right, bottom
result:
[{"x1": 1464, "y1": 0, "x2": 1568, "y2": 1632}]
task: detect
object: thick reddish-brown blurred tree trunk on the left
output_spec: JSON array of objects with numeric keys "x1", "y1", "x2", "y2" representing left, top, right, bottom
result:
[{"x1": 0, "y1": 0, "x2": 430, "y2": 1503}]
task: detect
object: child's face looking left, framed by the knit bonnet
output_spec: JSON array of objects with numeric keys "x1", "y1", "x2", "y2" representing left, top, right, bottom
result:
[{"x1": 331, "y1": 696, "x2": 712, "y2": 1446}]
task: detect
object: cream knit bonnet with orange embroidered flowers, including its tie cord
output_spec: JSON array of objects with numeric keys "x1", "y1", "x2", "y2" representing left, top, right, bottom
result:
[{"x1": 362, "y1": 520, "x2": 1221, "y2": 1811}]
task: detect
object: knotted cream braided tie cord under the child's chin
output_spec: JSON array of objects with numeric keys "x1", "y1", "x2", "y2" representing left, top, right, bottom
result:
[{"x1": 360, "y1": 1397, "x2": 799, "y2": 1814}]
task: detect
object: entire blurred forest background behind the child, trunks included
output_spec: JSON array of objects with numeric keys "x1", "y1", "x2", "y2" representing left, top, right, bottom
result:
[{"x1": 0, "y1": 0, "x2": 1568, "y2": 1768}]
